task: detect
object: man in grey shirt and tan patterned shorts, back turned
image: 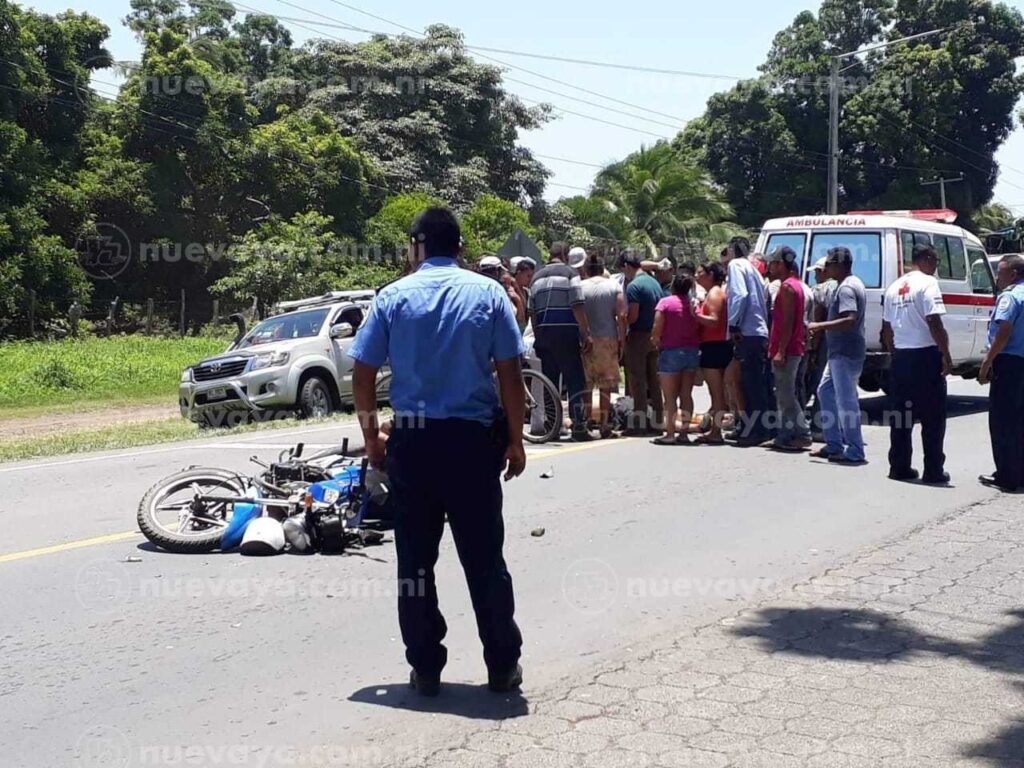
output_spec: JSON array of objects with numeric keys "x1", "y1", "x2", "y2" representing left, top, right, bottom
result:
[{"x1": 583, "y1": 256, "x2": 627, "y2": 439}]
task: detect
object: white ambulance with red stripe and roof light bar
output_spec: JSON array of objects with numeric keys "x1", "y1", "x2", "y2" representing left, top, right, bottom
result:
[{"x1": 757, "y1": 209, "x2": 996, "y2": 392}]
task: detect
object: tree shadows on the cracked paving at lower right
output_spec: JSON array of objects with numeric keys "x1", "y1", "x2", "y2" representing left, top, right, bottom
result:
[{"x1": 730, "y1": 608, "x2": 1024, "y2": 767}]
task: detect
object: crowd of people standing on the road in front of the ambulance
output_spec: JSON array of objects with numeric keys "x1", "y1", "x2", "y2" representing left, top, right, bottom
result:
[{"x1": 478, "y1": 231, "x2": 1024, "y2": 489}]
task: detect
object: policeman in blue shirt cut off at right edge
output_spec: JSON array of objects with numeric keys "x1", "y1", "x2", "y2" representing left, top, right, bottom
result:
[{"x1": 978, "y1": 256, "x2": 1024, "y2": 493}]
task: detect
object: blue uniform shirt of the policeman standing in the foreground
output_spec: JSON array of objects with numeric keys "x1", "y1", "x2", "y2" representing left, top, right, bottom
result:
[{"x1": 348, "y1": 258, "x2": 525, "y2": 424}]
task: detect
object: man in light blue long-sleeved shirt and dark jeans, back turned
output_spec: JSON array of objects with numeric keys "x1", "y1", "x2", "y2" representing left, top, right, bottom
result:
[{"x1": 725, "y1": 238, "x2": 775, "y2": 446}]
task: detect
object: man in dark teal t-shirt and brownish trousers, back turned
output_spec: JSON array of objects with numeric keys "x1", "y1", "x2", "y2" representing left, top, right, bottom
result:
[{"x1": 623, "y1": 253, "x2": 665, "y2": 437}]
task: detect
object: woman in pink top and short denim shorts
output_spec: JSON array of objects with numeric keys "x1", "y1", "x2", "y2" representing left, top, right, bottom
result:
[{"x1": 650, "y1": 274, "x2": 700, "y2": 445}]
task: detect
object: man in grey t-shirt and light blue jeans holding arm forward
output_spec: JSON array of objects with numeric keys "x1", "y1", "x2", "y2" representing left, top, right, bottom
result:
[{"x1": 809, "y1": 246, "x2": 867, "y2": 466}]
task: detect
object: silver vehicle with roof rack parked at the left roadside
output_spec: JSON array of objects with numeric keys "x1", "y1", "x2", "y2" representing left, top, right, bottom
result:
[{"x1": 178, "y1": 291, "x2": 390, "y2": 426}]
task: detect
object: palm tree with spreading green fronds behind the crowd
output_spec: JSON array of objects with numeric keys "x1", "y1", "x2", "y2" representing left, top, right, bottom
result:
[{"x1": 593, "y1": 142, "x2": 739, "y2": 257}]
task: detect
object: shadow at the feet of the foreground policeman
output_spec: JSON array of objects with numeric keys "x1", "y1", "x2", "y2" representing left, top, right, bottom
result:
[{"x1": 348, "y1": 683, "x2": 529, "y2": 720}]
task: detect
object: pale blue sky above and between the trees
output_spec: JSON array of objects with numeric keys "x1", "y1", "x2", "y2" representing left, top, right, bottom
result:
[{"x1": 27, "y1": 0, "x2": 1024, "y2": 215}]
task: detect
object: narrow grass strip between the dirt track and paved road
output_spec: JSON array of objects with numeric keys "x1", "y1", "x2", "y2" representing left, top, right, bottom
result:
[{"x1": 0, "y1": 414, "x2": 354, "y2": 462}]
